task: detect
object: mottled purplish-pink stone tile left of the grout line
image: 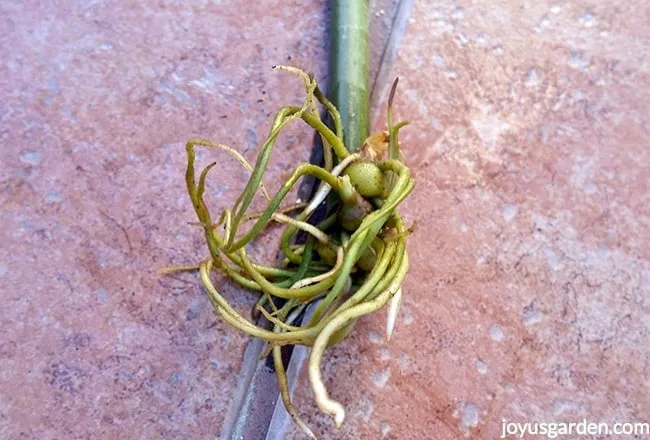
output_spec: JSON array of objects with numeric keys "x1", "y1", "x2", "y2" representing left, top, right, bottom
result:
[{"x1": 0, "y1": 1, "x2": 327, "y2": 439}]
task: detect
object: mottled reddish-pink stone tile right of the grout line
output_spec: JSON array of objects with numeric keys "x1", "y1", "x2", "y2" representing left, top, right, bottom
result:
[{"x1": 287, "y1": 1, "x2": 650, "y2": 440}]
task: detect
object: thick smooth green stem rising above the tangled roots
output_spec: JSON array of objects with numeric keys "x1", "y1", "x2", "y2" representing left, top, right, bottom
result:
[{"x1": 328, "y1": 0, "x2": 370, "y2": 153}]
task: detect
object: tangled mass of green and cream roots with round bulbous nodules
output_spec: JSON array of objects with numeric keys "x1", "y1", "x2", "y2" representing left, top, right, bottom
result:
[{"x1": 161, "y1": 66, "x2": 415, "y2": 438}]
